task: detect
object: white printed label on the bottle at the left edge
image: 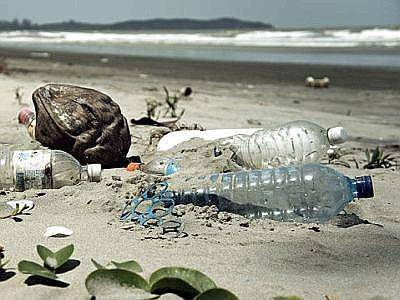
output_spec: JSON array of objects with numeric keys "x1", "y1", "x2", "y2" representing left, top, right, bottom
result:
[{"x1": 13, "y1": 150, "x2": 52, "y2": 191}]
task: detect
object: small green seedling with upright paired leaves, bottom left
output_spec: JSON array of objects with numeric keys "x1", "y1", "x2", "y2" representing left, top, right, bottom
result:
[{"x1": 18, "y1": 244, "x2": 74, "y2": 280}]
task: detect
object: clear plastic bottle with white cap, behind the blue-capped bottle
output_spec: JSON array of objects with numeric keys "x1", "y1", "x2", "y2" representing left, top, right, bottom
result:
[{"x1": 225, "y1": 121, "x2": 347, "y2": 169}]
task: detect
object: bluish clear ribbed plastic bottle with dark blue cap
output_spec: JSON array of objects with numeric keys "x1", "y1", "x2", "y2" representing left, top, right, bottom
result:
[{"x1": 173, "y1": 164, "x2": 374, "y2": 222}]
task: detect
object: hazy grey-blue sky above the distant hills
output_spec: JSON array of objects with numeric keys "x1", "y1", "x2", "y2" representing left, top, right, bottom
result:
[{"x1": 0, "y1": 0, "x2": 400, "y2": 27}]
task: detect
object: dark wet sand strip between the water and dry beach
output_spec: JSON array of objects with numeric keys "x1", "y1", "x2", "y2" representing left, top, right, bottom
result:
[{"x1": 0, "y1": 48, "x2": 400, "y2": 90}]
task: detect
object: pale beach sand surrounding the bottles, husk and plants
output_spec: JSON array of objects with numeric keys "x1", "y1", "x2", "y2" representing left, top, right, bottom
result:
[{"x1": 0, "y1": 50, "x2": 400, "y2": 300}]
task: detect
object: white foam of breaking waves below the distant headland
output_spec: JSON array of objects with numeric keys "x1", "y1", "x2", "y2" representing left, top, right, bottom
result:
[{"x1": 0, "y1": 28, "x2": 400, "y2": 48}]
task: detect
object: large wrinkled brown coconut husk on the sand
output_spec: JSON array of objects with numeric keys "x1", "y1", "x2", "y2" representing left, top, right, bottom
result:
[{"x1": 32, "y1": 84, "x2": 131, "y2": 168}]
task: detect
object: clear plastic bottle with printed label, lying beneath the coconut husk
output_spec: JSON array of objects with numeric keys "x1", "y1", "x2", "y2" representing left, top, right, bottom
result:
[{"x1": 0, "y1": 146, "x2": 101, "y2": 191}]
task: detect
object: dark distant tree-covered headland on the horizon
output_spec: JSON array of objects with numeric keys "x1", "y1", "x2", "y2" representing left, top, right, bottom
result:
[{"x1": 0, "y1": 18, "x2": 273, "y2": 31}]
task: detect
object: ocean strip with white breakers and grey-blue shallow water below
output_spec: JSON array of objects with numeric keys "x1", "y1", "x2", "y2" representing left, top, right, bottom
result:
[{"x1": 0, "y1": 28, "x2": 400, "y2": 68}]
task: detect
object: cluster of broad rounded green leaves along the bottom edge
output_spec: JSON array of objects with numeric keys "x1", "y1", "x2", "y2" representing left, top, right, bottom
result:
[{"x1": 85, "y1": 259, "x2": 238, "y2": 300}]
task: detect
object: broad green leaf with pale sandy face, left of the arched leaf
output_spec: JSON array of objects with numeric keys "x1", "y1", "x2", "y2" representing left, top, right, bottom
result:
[{"x1": 85, "y1": 269, "x2": 150, "y2": 299}]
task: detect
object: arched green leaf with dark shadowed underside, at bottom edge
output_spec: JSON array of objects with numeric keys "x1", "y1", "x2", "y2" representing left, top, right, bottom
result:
[{"x1": 149, "y1": 267, "x2": 217, "y2": 298}]
